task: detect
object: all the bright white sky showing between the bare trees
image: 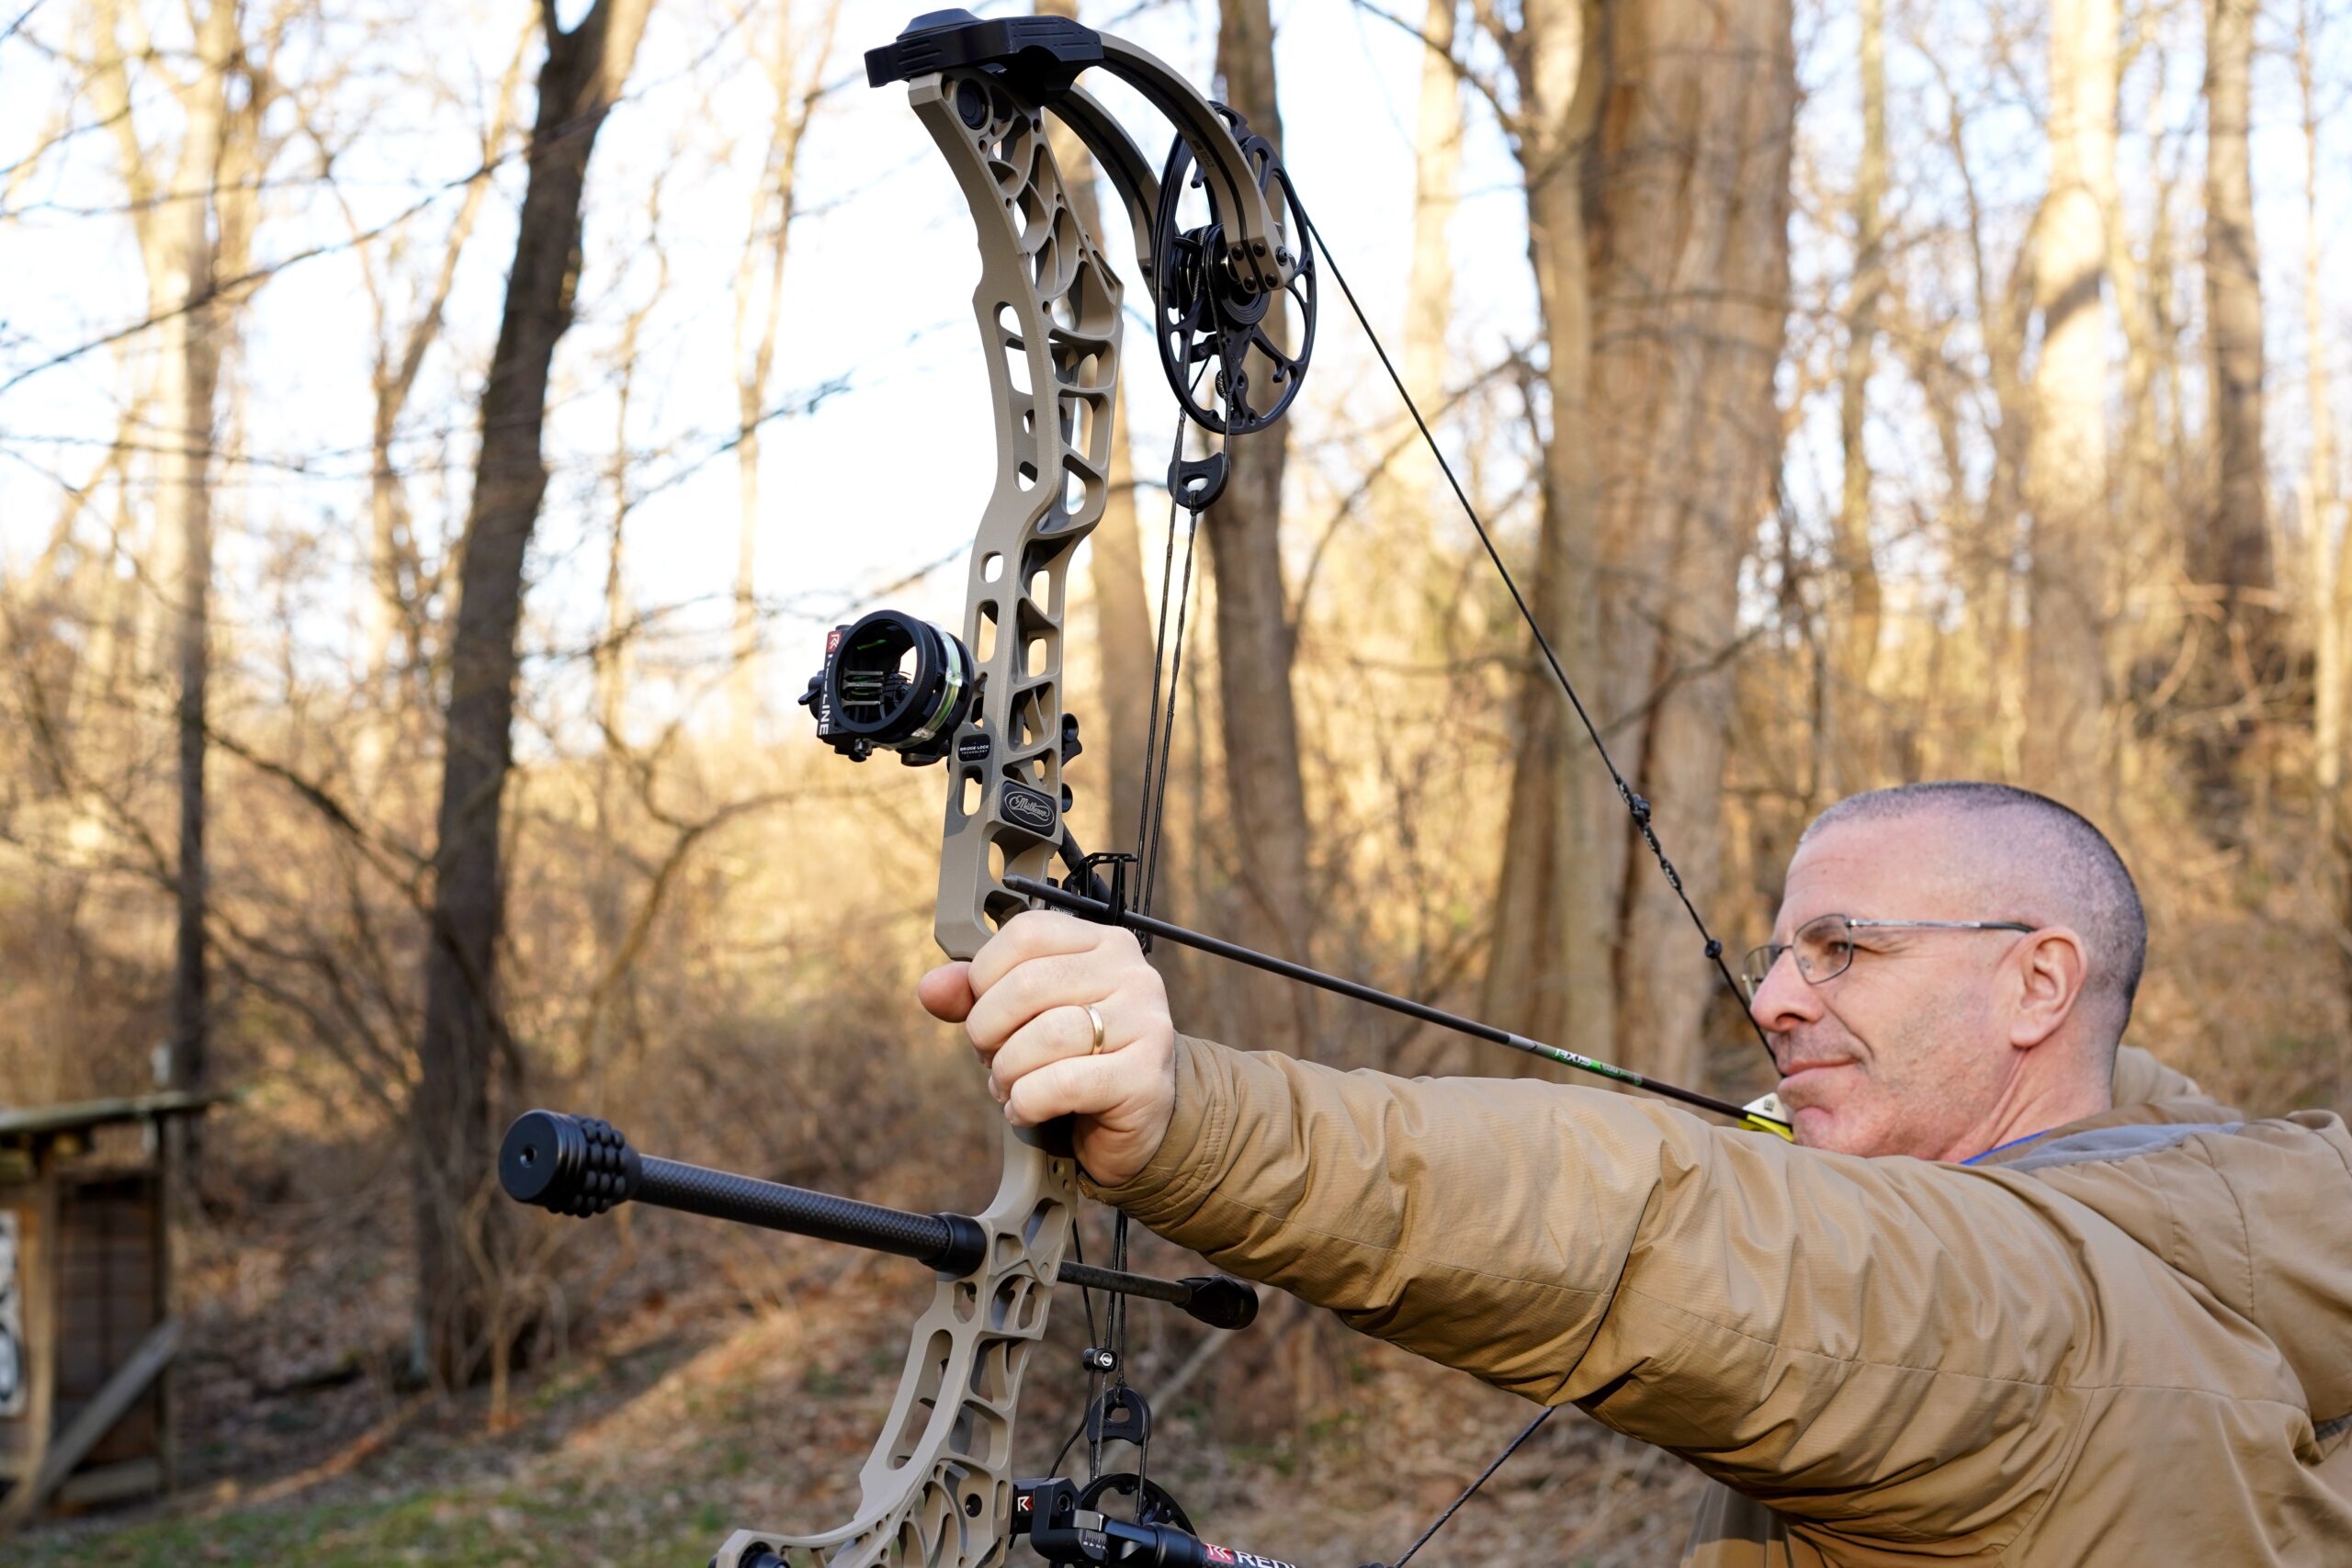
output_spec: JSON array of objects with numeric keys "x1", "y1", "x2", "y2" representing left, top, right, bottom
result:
[{"x1": 0, "y1": 0, "x2": 2352, "y2": 747}]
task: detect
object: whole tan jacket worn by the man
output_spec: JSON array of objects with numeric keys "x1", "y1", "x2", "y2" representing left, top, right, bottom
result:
[{"x1": 1096, "y1": 1039, "x2": 2352, "y2": 1568}]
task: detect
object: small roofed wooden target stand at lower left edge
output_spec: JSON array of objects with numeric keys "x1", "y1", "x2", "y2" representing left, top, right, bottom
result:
[{"x1": 0, "y1": 1093, "x2": 228, "y2": 1533}]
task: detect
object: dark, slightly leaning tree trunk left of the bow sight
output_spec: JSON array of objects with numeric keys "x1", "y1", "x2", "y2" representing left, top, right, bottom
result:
[{"x1": 412, "y1": 0, "x2": 650, "y2": 1384}]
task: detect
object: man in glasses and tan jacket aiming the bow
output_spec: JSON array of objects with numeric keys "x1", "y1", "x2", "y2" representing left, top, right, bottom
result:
[{"x1": 922, "y1": 783, "x2": 2352, "y2": 1568}]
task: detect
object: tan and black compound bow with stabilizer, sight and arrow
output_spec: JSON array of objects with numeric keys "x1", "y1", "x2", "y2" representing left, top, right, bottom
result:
[{"x1": 499, "y1": 12, "x2": 1788, "y2": 1568}]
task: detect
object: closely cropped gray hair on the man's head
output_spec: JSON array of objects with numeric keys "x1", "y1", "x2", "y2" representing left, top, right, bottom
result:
[{"x1": 1799, "y1": 781, "x2": 2147, "y2": 1046}]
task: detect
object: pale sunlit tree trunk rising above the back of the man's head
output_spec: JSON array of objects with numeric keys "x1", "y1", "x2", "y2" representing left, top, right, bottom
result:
[{"x1": 2020, "y1": 0, "x2": 2117, "y2": 816}]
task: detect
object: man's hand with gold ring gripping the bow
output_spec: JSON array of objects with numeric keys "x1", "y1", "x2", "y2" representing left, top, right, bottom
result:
[{"x1": 915, "y1": 909, "x2": 1176, "y2": 1187}]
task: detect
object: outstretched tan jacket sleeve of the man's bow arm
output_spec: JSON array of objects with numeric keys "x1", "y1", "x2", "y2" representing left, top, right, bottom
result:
[{"x1": 1096, "y1": 1042, "x2": 2150, "y2": 1547}]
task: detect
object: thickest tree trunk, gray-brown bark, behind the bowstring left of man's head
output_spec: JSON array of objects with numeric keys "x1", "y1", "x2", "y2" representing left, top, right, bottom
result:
[{"x1": 1484, "y1": 0, "x2": 1794, "y2": 1090}]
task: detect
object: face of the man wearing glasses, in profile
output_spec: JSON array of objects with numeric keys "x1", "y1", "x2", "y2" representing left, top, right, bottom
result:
[{"x1": 1750, "y1": 813, "x2": 2018, "y2": 1159}]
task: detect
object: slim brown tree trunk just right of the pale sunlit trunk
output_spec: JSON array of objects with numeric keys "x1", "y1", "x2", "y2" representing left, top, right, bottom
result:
[{"x1": 2188, "y1": 0, "x2": 2277, "y2": 832}]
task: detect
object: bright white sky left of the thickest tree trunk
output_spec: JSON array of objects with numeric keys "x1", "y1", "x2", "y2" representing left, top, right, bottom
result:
[{"x1": 0, "y1": 0, "x2": 1529, "y2": 738}]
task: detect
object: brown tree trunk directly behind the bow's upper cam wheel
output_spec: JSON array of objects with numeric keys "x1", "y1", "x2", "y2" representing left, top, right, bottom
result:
[{"x1": 1202, "y1": 0, "x2": 1322, "y2": 1055}]
